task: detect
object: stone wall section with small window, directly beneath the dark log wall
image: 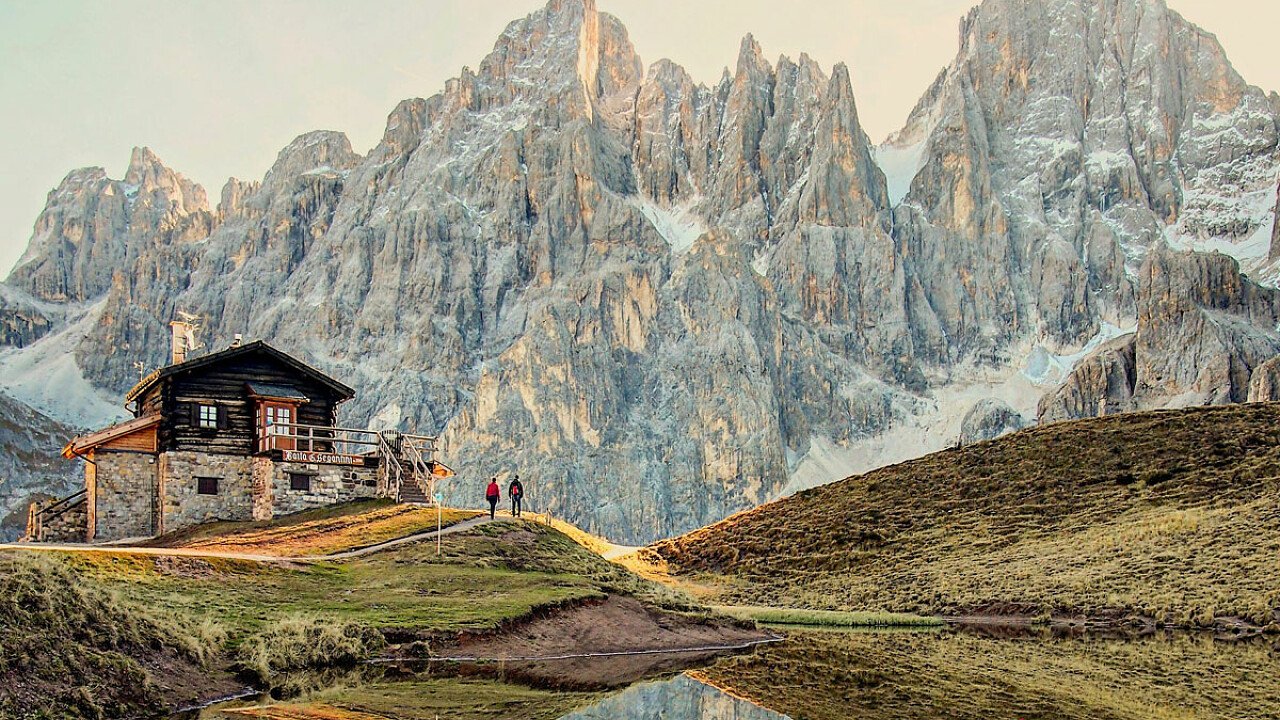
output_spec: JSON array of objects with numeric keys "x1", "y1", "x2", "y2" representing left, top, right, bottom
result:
[{"x1": 160, "y1": 452, "x2": 253, "y2": 533}]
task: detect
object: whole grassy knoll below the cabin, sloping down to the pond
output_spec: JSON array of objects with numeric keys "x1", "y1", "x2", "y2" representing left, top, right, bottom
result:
[{"x1": 0, "y1": 502, "x2": 704, "y2": 717}]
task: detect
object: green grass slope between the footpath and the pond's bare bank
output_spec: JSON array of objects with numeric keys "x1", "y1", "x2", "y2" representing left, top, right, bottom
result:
[{"x1": 72, "y1": 524, "x2": 619, "y2": 642}]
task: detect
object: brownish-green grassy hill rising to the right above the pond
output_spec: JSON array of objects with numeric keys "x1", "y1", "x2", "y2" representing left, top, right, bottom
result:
[{"x1": 641, "y1": 405, "x2": 1280, "y2": 625}]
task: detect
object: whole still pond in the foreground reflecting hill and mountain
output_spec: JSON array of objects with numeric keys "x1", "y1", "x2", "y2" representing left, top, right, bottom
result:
[{"x1": 182, "y1": 629, "x2": 1280, "y2": 720}]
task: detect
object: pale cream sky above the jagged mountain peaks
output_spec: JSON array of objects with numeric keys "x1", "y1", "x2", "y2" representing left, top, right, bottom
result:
[{"x1": 0, "y1": 0, "x2": 1280, "y2": 275}]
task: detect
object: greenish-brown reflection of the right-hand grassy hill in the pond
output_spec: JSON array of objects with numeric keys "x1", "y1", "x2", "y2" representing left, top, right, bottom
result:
[{"x1": 695, "y1": 628, "x2": 1280, "y2": 720}]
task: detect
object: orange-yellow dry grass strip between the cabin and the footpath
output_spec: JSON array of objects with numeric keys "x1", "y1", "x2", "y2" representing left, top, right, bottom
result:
[{"x1": 148, "y1": 502, "x2": 480, "y2": 557}]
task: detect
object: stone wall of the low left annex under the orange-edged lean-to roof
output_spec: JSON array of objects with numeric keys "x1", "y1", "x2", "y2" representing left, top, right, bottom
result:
[{"x1": 88, "y1": 450, "x2": 157, "y2": 542}]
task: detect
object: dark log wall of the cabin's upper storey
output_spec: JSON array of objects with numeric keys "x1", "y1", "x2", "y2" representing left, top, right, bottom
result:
[{"x1": 160, "y1": 357, "x2": 338, "y2": 455}]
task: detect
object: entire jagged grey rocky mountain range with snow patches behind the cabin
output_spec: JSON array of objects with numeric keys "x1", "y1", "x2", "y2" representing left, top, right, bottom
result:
[{"x1": 0, "y1": 0, "x2": 1280, "y2": 541}]
